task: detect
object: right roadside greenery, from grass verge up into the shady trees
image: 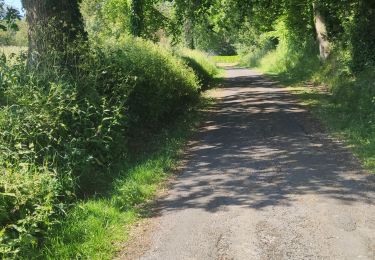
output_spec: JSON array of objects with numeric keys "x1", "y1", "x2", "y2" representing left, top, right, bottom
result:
[{"x1": 241, "y1": 1, "x2": 375, "y2": 172}]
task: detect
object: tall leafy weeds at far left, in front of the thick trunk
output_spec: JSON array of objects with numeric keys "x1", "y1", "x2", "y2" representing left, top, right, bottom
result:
[{"x1": 0, "y1": 50, "x2": 124, "y2": 257}]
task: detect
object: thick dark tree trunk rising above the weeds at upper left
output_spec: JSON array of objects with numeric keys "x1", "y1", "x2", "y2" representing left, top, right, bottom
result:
[{"x1": 22, "y1": 0, "x2": 86, "y2": 64}]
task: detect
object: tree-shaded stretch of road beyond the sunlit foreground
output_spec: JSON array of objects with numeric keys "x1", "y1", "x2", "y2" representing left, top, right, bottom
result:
[{"x1": 159, "y1": 70, "x2": 375, "y2": 212}]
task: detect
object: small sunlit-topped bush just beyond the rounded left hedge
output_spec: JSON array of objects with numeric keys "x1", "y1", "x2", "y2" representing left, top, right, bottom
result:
[{"x1": 177, "y1": 49, "x2": 219, "y2": 90}]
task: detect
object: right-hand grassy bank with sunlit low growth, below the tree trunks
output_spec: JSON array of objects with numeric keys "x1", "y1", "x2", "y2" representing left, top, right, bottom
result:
[{"x1": 241, "y1": 27, "x2": 375, "y2": 173}]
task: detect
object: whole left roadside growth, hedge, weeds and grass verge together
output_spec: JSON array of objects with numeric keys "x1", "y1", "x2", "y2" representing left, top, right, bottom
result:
[{"x1": 0, "y1": 1, "x2": 218, "y2": 259}]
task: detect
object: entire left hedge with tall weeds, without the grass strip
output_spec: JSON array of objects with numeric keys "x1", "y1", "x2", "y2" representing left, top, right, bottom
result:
[{"x1": 0, "y1": 39, "x2": 203, "y2": 257}]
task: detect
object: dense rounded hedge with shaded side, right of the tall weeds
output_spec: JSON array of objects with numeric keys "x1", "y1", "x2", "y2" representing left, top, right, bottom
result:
[{"x1": 107, "y1": 38, "x2": 200, "y2": 128}]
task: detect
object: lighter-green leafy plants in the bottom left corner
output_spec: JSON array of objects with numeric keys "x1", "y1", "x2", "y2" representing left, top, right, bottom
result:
[{"x1": 0, "y1": 165, "x2": 61, "y2": 258}]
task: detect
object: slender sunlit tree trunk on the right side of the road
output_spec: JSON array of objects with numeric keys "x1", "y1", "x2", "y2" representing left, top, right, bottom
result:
[{"x1": 313, "y1": 3, "x2": 331, "y2": 61}]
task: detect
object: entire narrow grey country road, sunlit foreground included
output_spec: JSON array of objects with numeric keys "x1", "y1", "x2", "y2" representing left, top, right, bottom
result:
[{"x1": 140, "y1": 68, "x2": 375, "y2": 260}]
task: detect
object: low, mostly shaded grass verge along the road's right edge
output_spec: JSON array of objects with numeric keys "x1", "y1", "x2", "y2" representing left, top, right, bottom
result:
[{"x1": 270, "y1": 74, "x2": 375, "y2": 173}]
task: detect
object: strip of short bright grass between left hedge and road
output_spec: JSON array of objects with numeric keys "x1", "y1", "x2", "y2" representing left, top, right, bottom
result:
[{"x1": 33, "y1": 95, "x2": 216, "y2": 259}]
